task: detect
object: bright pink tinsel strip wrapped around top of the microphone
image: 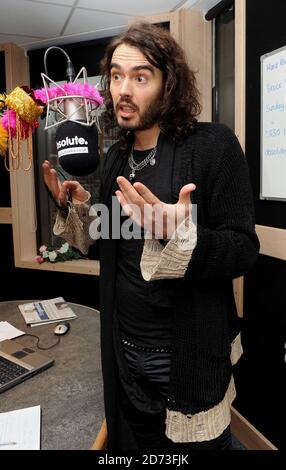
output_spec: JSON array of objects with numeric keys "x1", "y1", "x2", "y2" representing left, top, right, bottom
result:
[{"x1": 34, "y1": 83, "x2": 104, "y2": 106}]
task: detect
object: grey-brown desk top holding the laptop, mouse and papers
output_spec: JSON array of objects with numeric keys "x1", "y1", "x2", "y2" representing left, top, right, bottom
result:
[{"x1": 0, "y1": 300, "x2": 104, "y2": 450}]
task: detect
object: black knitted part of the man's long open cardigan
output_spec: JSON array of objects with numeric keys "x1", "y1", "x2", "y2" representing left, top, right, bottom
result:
[{"x1": 97, "y1": 123, "x2": 259, "y2": 450}]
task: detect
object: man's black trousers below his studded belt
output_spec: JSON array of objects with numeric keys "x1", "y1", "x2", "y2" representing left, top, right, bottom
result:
[{"x1": 120, "y1": 346, "x2": 232, "y2": 454}]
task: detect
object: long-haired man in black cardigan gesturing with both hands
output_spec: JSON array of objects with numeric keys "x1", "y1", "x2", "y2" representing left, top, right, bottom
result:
[{"x1": 43, "y1": 23, "x2": 259, "y2": 454}]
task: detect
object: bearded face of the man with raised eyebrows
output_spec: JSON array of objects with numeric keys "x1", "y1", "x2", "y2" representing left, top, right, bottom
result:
[{"x1": 110, "y1": 44, "x2": 163, "y2": 131}]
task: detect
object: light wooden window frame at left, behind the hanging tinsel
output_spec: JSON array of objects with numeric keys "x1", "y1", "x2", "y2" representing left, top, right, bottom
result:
[{"x1": 0, "y1": 44, "x2": 99, "y2": 276}]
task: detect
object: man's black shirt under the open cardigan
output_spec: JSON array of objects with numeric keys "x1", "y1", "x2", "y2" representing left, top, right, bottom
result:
[{"x1": 116, "y1": 138, "x2": 173, "y2": 347}]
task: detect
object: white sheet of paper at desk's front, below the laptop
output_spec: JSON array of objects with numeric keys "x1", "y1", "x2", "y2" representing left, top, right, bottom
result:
[{"x1": 0, "y1": 405, "x2": 41, "y2": 450}]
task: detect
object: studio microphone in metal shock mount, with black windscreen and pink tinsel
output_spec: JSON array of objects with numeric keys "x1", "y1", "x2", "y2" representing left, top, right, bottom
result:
[{"x1": 38, "y1": 46, "x2": 103, "y2": 176}]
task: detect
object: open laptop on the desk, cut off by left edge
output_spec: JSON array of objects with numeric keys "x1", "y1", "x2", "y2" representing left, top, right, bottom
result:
[{"x1": 0, "y1": 339, "x2": 54, "y2": 393}]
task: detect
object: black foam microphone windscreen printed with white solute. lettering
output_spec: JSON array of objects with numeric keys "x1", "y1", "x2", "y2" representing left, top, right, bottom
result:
[{"x1": 56, "y1": 121, "x2": 99, "y2": 176}]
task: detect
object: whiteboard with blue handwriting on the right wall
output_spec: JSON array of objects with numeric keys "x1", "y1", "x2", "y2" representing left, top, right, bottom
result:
[{"x1": 260, "y1": 46, "x2": 286, "y2": 200}]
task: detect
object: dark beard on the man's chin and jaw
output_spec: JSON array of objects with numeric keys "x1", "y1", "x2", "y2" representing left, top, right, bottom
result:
[{"x1": 116, "y1": 93, "x2": 162, "y2": 131}]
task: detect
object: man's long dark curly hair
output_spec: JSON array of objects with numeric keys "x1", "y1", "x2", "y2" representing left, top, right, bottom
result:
[{"x1": 100, "y1": 22, "x2": 201, "y2": 147}]
